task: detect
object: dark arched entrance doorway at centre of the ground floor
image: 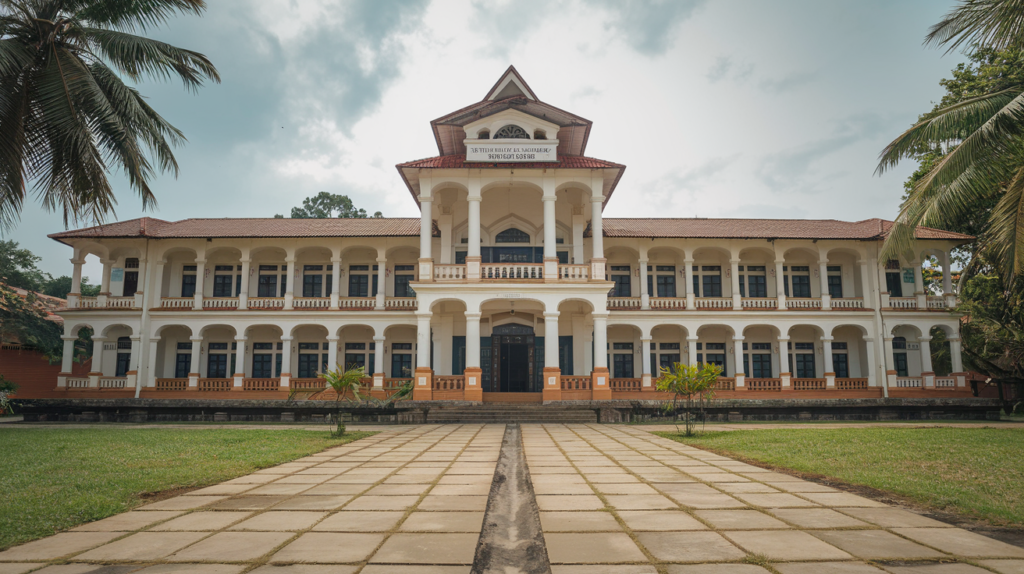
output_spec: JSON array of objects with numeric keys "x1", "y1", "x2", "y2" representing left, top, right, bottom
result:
[{"x1": 489, "y1": 324, "x2": 537, "y2": 393}]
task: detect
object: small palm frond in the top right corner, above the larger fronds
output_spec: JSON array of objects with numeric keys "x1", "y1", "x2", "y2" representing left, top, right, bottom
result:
[{"x1": 925, "y1": 0, "x2": 1024, "y2": 53}]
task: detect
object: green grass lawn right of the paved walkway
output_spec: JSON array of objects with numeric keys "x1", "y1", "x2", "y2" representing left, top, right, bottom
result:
[{"x1": 655, "y1": 428, "x2": 1024, "y2": 526}]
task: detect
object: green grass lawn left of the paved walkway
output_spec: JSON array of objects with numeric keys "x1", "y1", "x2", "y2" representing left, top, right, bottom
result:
[{"x1": 0, "y1": 428, "x2": 375, "y2": 549}]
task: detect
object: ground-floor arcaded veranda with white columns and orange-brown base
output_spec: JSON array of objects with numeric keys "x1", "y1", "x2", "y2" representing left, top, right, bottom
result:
[{"x1": 56, "y1": 294, "x2": 968, "y2": 401}]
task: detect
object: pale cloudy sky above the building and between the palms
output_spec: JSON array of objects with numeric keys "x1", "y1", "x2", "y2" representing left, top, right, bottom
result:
[{"x1": 7, "y1": 0, "x2": 963, "y2": 279}]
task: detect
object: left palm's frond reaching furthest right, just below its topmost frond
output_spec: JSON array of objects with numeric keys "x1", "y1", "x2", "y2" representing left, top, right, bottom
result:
[{"x1": 83, "y1": 28, "x2": 220, "y2": 91}]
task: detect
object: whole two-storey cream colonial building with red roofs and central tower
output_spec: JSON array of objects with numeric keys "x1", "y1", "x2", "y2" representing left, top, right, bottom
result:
[{"x1": 51, "y1": 68, "x2": 972, "y2": 401}]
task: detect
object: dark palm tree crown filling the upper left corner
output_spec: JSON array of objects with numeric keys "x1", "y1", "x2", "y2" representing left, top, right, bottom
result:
[{"x1": 0, "y1": 0, "x2": 220, "y2": 231}]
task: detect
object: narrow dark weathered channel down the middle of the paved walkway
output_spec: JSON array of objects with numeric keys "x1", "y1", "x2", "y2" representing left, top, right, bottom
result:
[{"x1": 471, "y1": 424, "x2": 551, "y2": 574}]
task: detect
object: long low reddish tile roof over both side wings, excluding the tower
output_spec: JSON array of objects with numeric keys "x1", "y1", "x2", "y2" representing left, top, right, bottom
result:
[{"x1": 49, "y1": 214, "x2": 974, "y2": 241}]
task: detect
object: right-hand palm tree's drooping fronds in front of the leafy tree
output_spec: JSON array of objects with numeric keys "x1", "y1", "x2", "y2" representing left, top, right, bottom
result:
[{"x1": 877, "y1": 0, "x2": 1024, "y2": 279}]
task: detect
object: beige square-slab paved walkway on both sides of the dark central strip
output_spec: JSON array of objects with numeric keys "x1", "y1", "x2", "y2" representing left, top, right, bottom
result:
[{"x1": 0, "y1": 425, "x2": 1024, "y2": 574}]
